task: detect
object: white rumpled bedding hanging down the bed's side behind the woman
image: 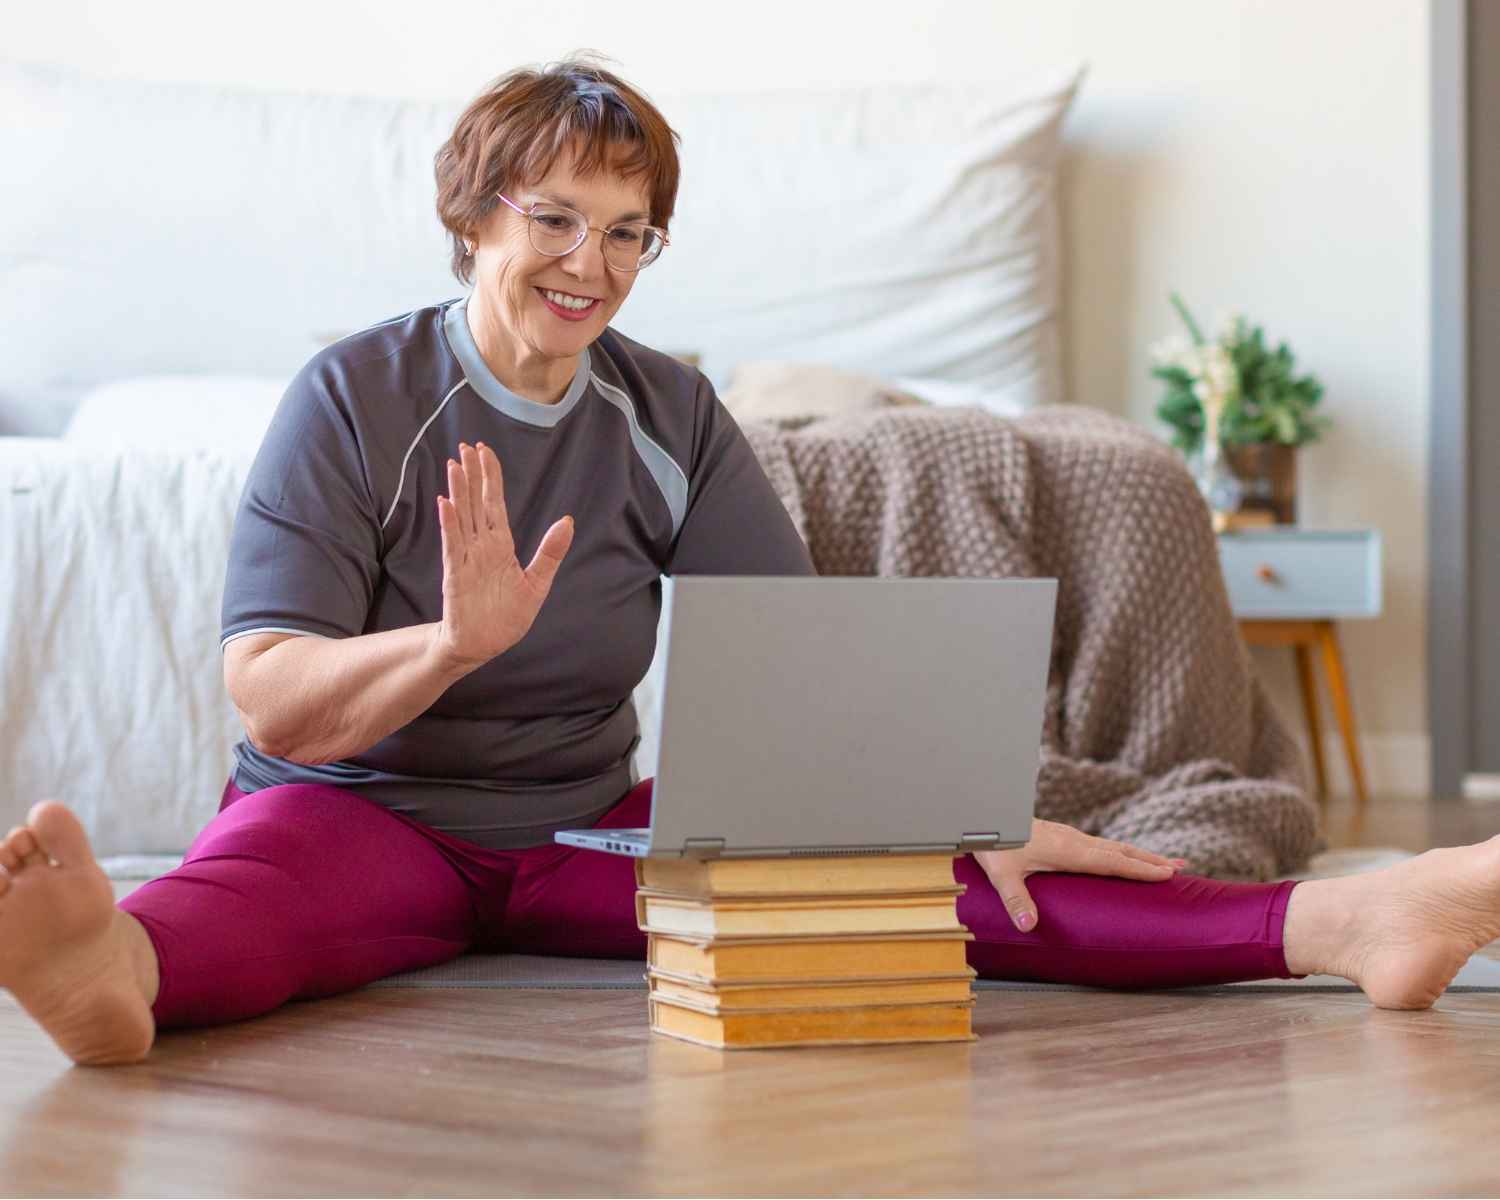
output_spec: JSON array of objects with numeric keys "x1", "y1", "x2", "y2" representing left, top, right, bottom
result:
[{"x1": 0, "y1": 438, "x2": 659, "y2": 855}]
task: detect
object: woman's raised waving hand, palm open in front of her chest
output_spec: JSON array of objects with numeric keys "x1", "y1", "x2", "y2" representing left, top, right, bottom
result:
[{"x1": 437, "y1": 443, "x2": 573, "y2": 671}]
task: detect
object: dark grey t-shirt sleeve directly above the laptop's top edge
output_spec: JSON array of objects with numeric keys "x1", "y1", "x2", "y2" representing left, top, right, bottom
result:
[{"x1": 666, "y1": 377, "x2": 818, "y2": 575}]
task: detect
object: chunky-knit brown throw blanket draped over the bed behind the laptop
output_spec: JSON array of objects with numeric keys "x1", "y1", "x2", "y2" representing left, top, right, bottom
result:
[{"x1": 746, "y1": 408, "x2": 1320, "y2": 879}]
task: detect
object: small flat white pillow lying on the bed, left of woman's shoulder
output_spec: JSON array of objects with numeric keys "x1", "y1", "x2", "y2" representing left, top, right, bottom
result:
[{"x1": 63, "y1": 375, "x2": 290, "y2": 453}]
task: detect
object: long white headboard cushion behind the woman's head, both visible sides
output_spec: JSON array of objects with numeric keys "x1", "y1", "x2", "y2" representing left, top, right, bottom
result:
[{"x1": 0, "y1": 63, "x2": 1082, "y2": 434}]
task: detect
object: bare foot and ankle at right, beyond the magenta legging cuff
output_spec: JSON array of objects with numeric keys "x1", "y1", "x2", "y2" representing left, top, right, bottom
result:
[{"x1": 1284, "y1": 837, "x2": 1500, "y2": 1008}]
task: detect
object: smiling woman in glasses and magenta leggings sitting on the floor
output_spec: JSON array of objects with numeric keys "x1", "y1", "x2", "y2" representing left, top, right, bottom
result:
[{"x1": 0, "y1": 63, "x2": 1500, "y2": 1064}]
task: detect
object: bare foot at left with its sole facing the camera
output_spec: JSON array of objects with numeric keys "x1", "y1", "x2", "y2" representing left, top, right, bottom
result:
[{"x1": 0, "y1": 800, "x2": 158, "y2": 1065}]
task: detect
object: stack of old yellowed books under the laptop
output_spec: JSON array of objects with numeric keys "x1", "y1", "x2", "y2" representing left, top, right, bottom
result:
[{"x1": 636, "y1": 855, "x2": 974, "y2": 1049}]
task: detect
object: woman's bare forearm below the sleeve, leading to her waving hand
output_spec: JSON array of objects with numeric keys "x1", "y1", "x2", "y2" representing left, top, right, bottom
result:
[{"x1": 236, "y1": 623, "x2": 473, "y2": 765}]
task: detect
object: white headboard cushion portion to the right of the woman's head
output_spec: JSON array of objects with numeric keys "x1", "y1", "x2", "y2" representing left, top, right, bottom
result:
[{"x1": 615, "y1": 68, "x2": 1083, "y2": 410}]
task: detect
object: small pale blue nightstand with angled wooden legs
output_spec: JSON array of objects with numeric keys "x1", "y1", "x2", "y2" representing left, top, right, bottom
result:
[{"x1": 1218, "y1": 525, "x2": 1382, "y2": 804}]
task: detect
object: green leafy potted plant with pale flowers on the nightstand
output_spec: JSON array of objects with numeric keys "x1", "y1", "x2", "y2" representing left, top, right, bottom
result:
[{"x1": 1151, "y1": 293, "x2": 1328, "y2": 525}]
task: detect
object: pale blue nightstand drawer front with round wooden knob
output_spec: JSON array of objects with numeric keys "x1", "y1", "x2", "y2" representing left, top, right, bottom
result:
[{"x1": 1218, "y1": 528, "x2": 1382, "y2": 621}]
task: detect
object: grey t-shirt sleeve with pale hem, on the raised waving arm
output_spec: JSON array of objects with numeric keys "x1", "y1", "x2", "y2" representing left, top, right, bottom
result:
[{"x1": 219, "y1": 360, "x2": 381, "y2": 650}]
